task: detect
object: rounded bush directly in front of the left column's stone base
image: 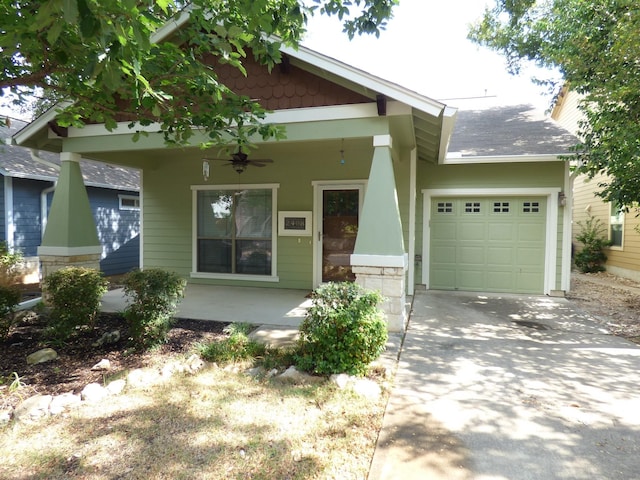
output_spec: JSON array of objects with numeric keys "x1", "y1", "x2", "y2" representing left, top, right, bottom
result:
[{"x1": 44, "y1": 267, "x2": 107, "y2": 342}]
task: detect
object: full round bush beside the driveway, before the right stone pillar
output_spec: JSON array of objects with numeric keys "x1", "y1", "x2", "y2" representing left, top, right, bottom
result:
[{"x1": 295, "y1": 282, "x2": 387, "y2": 375}]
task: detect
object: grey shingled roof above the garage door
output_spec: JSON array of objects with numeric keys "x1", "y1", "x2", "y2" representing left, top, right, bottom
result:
[{"x1": 447, "y1": 104, "x2": 577, "y2": 158}]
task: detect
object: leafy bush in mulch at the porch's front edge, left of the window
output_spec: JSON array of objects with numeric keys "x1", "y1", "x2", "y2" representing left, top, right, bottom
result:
[{"x1": 123, "y1": 269, "x2": 186, "y2": 349}]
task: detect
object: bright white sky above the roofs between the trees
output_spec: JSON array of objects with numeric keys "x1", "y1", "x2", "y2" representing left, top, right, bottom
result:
[{"x1": 0, "y1": 0, "x2": 550, "y2": 118}]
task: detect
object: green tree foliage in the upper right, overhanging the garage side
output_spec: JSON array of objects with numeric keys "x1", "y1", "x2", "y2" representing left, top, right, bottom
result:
[{"x1": 469, "y1": 0, "x2": 640, "y2": 208}]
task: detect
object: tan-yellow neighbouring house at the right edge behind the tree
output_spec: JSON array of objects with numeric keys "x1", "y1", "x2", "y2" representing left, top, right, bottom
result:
[{"x1": 552, "y1": 88, "x2": 640, "y2": 280}]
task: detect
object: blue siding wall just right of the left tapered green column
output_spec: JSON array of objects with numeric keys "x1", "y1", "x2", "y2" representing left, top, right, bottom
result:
[{"x1": 87, "y1": 187, "x2": 140, "y2": 275}]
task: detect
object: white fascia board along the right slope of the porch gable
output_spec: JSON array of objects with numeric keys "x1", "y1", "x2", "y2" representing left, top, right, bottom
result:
[{"x1": 280, "y1": 45, "x2": 446, "y2": 117}]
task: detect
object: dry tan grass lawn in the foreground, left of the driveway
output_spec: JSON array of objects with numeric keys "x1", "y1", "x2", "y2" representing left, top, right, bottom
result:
[{"x1": 0, "y1": 368, "x2": 386, "y2": 480}]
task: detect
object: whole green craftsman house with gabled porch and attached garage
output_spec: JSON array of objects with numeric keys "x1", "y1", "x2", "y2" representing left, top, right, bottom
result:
[{"x1": 13, "y1": 38, "x2": 572, "y2": 331}]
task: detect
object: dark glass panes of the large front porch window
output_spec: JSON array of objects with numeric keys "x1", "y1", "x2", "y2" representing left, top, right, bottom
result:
[{"x1": 194, "y1": 186, "x2": 276, "y2": 277}]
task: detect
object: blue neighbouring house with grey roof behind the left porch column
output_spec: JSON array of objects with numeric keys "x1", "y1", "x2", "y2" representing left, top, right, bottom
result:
[{"x1": 0, "y1": 119, "x2": 140, "y2": 282}]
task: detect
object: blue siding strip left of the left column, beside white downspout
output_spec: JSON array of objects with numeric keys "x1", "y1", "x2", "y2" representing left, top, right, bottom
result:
[{"x1": 12, "y1": 178, "x2": 46, "y2": 257}]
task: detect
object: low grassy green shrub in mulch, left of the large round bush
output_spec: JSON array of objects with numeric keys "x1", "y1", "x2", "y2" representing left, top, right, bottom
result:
[{"x1": 198, "y1": 323, "x2": 267, "y2": 364}]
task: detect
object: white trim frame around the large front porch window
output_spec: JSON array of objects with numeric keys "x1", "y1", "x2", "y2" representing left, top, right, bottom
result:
[{"x1": 190, "y1": 183, "x2": 280, "y2": 283}]
